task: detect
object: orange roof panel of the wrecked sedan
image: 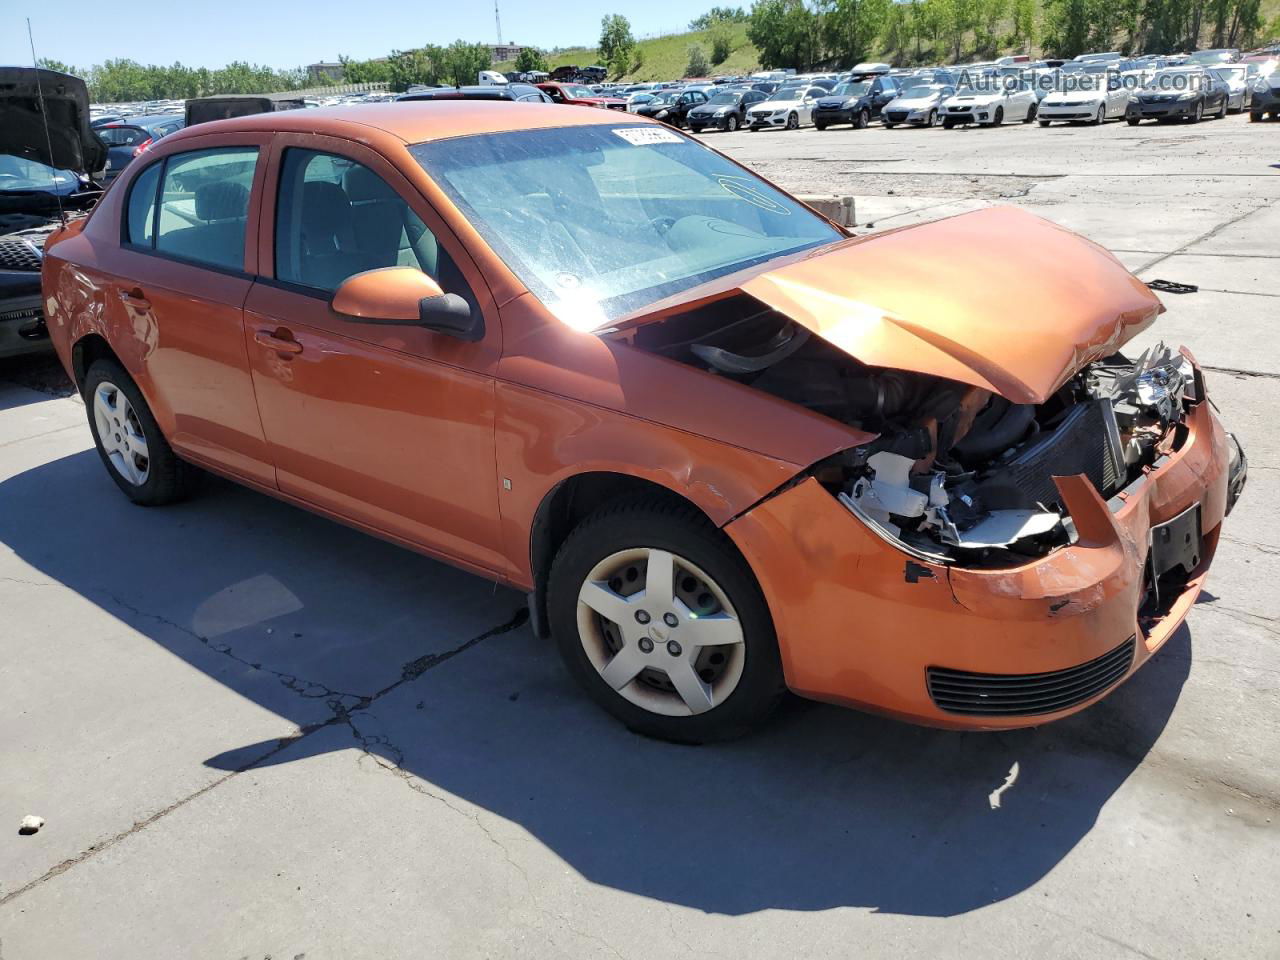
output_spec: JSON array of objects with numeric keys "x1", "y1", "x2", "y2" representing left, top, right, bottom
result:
[{"x1": 158, "y1": 100, "x2": 649, "y2": 143}]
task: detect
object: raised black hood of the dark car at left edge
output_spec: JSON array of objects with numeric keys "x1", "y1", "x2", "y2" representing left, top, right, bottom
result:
[{"x1": 0, "y1": 67, "x2": 106, "y2": 174}]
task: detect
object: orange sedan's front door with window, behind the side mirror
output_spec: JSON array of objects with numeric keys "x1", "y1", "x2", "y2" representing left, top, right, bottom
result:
[{"x1": 244, "y1": 134, "x2": 507, "y2": 575}]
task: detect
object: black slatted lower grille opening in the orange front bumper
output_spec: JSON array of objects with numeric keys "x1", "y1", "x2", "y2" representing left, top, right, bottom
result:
[{"x1": 927, "y1": 636, "x2": 1137, "y2": 717}]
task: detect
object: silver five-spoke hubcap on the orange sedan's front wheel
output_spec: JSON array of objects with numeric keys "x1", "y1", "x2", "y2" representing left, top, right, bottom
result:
[{"x1": 577, "y1": 548, "x2": 746, "y2": 717}]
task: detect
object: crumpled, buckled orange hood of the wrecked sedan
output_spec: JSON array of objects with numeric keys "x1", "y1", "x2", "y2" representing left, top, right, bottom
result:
[{"x1": 612, "y1": 207, "x2": 1164, "y2": 403}]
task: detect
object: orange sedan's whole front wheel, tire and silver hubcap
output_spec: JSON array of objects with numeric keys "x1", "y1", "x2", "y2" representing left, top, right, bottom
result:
[{"x1": 548, "y1": 500, "x2": 786, "y2": 742}]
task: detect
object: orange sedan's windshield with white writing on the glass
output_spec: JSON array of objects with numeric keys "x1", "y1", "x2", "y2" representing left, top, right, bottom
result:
[{"x1": 410, "y1": 124, "x2": 842, "y2": 330}]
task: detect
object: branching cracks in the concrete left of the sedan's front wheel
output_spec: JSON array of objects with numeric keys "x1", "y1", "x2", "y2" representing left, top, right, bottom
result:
[{"x1": 0, "y1": 609, "x2": 529, "y2": 906}]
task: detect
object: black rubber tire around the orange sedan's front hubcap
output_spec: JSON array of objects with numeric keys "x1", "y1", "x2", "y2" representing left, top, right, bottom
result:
[{"x1": 547, "y1": 498, "x2": 786, "y2": 744}]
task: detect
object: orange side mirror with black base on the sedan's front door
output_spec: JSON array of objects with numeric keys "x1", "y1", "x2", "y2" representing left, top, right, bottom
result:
[{"x1": 330, "y1": 266, "x2": 484, "y2": 342}]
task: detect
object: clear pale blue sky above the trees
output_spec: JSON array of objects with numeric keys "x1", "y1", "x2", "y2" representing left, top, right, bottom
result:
[{"x1": 0, "y1": 0, "x2": 701, "y2": 67}]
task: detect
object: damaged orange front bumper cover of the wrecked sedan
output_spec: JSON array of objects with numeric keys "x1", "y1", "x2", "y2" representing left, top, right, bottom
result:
[{"x1": 726, "y1": 360, "x2": 1245, "y2": 730}]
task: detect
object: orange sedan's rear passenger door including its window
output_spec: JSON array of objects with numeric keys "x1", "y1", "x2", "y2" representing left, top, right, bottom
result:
[{"x1": 102, "y1": 134, "x2": 274, "y2": 485}]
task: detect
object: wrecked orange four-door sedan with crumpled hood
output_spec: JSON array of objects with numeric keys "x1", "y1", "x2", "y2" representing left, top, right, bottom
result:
[{"x1": 44, "y1": 102, "x2": 1245, "y2": 741}]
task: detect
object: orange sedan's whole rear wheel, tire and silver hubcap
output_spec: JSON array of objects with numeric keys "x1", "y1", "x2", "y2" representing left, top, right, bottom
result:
[{"x1": 84, "y1": 357, "x2": 193, "y2": 507}]
